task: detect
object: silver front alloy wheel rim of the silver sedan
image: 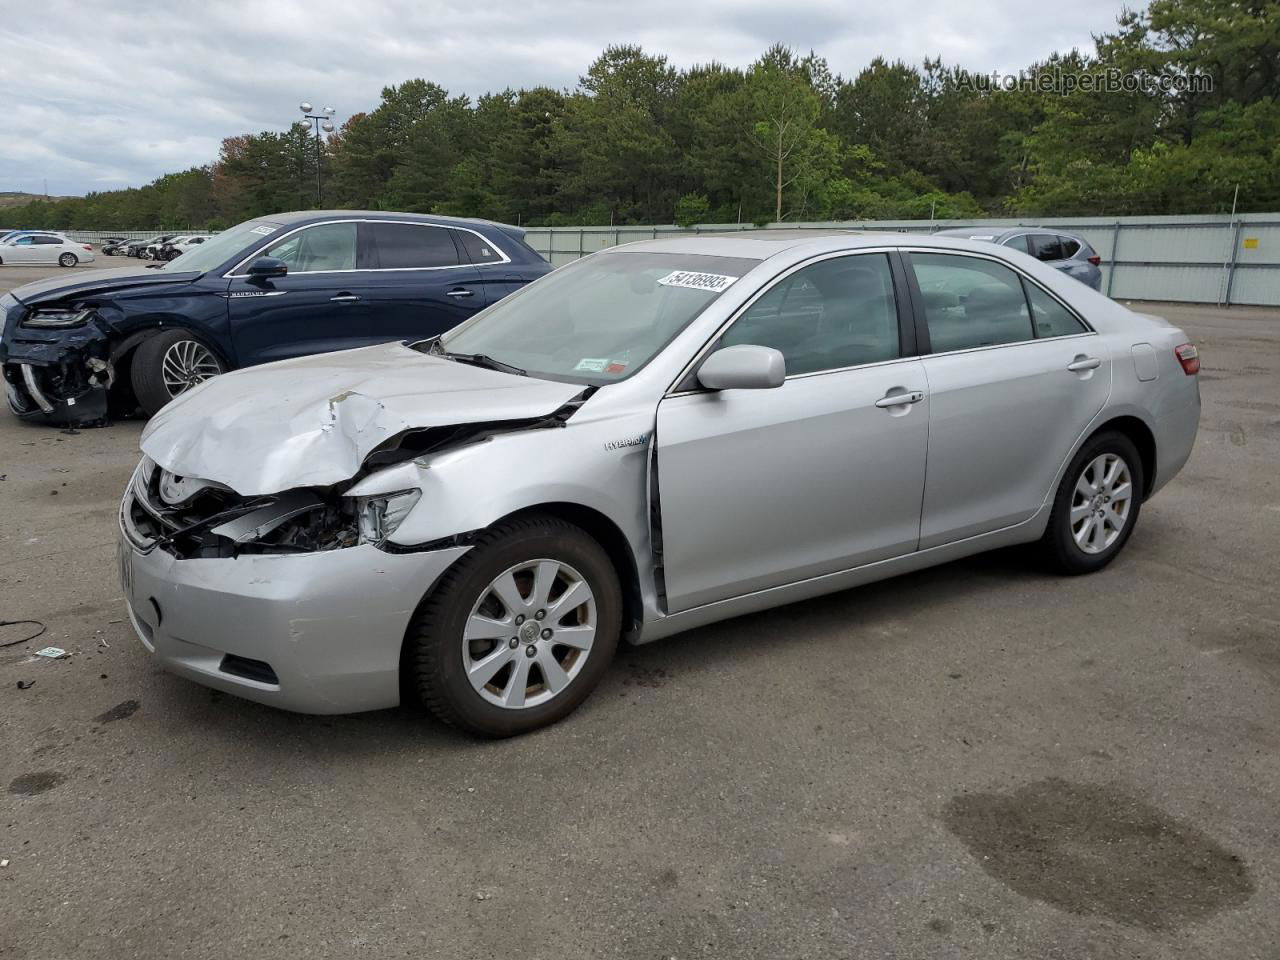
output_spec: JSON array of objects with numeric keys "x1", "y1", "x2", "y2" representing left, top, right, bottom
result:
[{"x1": 462, "y1": 558, "x2": 598, "y2": 709}]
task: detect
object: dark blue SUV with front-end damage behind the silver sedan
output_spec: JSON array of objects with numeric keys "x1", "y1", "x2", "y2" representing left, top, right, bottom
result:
[{"x1": 0, "y1": 210, "x2": 552, "y2": 424}]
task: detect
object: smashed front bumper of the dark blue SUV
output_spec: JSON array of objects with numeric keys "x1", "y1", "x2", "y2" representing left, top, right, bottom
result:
[{"x1": 0, "y1": 313, "x2": 114, "y2": 426}]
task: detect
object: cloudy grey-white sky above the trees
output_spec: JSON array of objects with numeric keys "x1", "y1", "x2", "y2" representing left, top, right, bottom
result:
[{"x1": 0, "y1": 0, "x2": 1133, "y2": 195}]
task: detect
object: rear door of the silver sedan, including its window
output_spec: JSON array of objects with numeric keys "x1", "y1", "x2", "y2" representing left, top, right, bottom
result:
[{"x1": 908, "y1": 251, "x2": 1111, "y2": 549}]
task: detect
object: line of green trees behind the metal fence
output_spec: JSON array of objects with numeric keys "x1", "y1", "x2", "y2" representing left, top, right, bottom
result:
[{"x1": 5, "y1": 0, "x2": 1280, "y2": 229}]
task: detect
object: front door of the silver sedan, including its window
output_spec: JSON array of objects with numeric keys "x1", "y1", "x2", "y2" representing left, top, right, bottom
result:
[{"x1": 655, "y1": 253, "x2": 929, "y2": 613}]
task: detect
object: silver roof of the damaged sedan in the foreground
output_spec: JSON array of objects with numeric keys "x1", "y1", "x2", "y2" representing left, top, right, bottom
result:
[{"x1": 602, "y1": 229, "x2": 1039, "y2": 260}]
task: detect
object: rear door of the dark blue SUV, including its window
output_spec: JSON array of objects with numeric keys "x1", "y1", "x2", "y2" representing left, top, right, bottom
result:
[{"x1": 364, "y1": 220, "x2": 486, "y2": 342}]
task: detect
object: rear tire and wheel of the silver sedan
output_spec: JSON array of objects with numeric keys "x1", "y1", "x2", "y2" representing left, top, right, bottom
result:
[{"x1": 1041, "y1": 433, "x2": 1146, "y2": 576}]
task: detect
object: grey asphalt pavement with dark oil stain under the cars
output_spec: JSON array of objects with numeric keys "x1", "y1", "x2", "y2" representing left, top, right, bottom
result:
[{"x1": 0, "y1": 267, "x2": 1280, "y2": 960}]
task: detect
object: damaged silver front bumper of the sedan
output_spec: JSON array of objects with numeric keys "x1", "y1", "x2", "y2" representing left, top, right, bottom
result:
[{"x1": 119, "y1": 463, "x2": 468, "y2": 713}]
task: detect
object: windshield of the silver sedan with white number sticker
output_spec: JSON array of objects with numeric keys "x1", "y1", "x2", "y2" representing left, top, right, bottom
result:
[{"x1": 438, "y1": 252, "x2": 759, "y2": 385}]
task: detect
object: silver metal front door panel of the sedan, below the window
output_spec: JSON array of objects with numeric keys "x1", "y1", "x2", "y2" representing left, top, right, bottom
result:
[{"x1": 657, "y1": 360, "x2": 929, "y2": 613}]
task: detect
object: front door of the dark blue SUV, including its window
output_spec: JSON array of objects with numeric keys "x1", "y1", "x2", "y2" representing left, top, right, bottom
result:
[{"x1": 227, "y1": 220, "x2": 371, "y2": 366}]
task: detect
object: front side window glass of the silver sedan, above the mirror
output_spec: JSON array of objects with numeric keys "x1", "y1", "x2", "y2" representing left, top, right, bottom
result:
[{"x1": 721, "y1": 253, "x2": 899, "y2": 375}]
